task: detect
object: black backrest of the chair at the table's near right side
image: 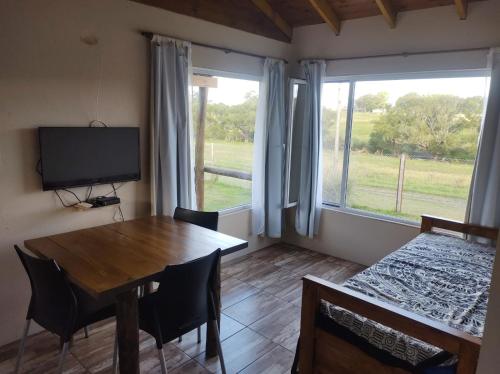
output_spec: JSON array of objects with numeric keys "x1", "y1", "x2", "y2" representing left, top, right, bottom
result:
[{"x1": 150, "y1": 249, "x2": 221, "y2": 343}]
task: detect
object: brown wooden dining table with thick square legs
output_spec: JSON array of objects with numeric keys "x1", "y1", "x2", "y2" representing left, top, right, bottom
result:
[{"x1": 24, "y1": 216, "x2": 248, "y2": 374}]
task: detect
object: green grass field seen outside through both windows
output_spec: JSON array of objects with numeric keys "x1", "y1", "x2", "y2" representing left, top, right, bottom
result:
[{"x1": 198, "y1": 113, "x2": 473, "y2": 221}]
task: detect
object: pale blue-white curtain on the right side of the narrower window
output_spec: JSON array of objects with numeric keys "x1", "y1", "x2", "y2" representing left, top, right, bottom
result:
[{"x1": 252, "y1": 58, "x2": 286, "y2": 238}]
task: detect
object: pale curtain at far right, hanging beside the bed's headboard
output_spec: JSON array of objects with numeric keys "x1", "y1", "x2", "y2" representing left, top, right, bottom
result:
[{"x1": 469, "y1": 48, "x2": 500, "y2": 227}]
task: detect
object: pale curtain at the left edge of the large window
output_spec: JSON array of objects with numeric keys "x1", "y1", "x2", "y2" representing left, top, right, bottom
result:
[{"x1": 294, "y1": 60, "x2": 326, "y2": 238}]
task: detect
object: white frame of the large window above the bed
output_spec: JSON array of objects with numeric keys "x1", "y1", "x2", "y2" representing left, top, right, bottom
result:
[{"x1": 323, "y1": 69, "x2": 491, "y2": 226}]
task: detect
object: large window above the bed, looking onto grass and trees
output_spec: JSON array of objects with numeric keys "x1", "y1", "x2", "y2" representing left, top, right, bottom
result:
[{"x1": 322, "y1": 75, "x2": 489, "y2": 221}]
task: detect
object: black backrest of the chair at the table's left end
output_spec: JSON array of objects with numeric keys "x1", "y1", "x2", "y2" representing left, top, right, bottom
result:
[{"x1": 14, "y1": 245, "x2": 77, "y2": 338}]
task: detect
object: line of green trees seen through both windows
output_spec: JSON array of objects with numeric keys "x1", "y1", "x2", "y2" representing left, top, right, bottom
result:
[{"x1": 193, "y1": 92, "x2": 483, "y2": 160}]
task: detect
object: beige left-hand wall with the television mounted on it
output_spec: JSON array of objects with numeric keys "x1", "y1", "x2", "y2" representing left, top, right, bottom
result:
[{"x1": 0, "y1": 0, "x2": 291, "y2": 345}]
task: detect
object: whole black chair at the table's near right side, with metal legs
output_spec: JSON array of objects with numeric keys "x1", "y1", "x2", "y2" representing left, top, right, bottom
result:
[{"x1": 139, "y1": 249, "x2": 226, "y2": 374}]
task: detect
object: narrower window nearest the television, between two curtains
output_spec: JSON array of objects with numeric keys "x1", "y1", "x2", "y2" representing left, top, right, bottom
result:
[{"x1": 192, "y1": 75, "x2": 259, "y2": 211}]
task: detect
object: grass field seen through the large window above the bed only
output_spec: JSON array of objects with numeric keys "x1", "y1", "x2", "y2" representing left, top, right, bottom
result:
[{"x1": 323, "y1": 151, "x2": 474, "y2": 220}]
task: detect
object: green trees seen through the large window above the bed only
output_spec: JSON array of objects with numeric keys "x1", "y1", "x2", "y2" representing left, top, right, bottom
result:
[{"x1": 324, "y1": 92, "x2": 483, "y2": 160}]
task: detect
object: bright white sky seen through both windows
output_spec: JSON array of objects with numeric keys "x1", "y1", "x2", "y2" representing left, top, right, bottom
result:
[{"x1": 194, "y1": 77, "x2": 489, "y2": 109}]
